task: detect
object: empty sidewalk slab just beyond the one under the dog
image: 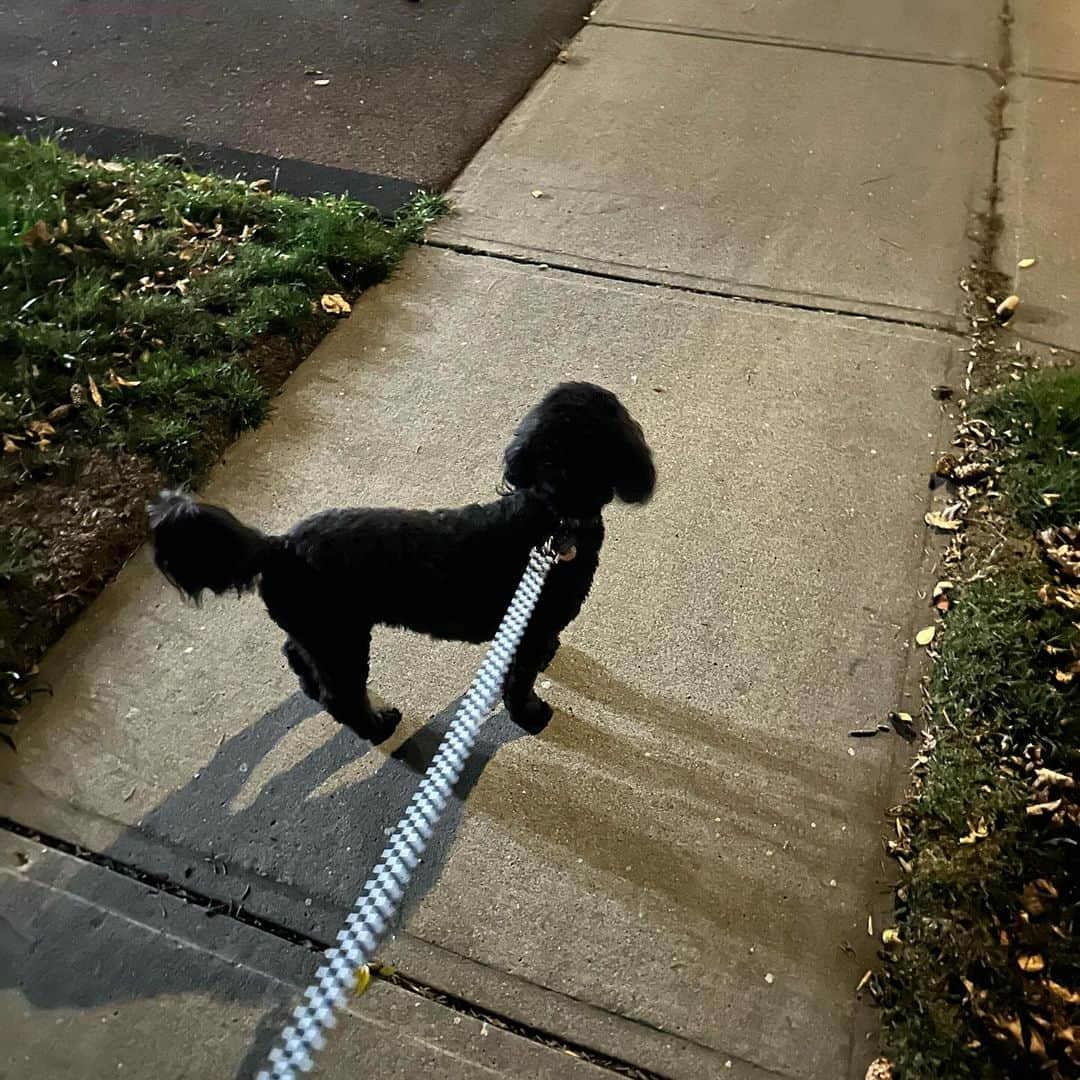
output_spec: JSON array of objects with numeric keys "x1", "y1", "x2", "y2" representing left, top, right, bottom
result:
[{"x1": 435, "y1": 27, "x2": 994, "y2": 325}]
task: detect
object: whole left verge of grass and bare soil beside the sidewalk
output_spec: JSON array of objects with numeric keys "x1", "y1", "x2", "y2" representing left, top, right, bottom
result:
[{"x1": 0, "y1": 138, "x2": 445, "y2": 738}]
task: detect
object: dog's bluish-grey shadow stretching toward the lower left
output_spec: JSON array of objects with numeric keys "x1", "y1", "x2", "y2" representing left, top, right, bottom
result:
[{"x1": 0, "y1": 693, "x2": 525, "y2": 1023}]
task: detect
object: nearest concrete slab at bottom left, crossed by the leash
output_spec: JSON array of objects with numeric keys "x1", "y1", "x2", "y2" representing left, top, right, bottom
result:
[{"x1": 0, "y1": 832, "x2": 610, "y2": 1080}]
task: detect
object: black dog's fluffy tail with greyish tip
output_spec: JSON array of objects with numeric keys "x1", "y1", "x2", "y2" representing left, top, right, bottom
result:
[{"x1": 148, "y1": 491, "x2": 276, "y2": 602}]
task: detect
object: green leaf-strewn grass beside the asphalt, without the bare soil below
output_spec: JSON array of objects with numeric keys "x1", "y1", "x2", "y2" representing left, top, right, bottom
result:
[{"x1": 0, "y1": 138, "x2": 445, "y2": 482}]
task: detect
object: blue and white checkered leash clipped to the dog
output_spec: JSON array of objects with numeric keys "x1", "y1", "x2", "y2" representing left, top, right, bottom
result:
[{"x1": 258, "y1": 543, "x2": 557, "y2": 1080}]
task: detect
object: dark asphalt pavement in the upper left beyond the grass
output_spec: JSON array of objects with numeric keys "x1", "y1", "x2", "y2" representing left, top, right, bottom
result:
[{"x1": 0, "y1": 0, "x2": 592, "y2": 187}]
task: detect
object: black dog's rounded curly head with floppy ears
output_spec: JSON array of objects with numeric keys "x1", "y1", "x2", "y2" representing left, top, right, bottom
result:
[{"x1": 503, "y1": 382, "x2": 657, "y2": 518}]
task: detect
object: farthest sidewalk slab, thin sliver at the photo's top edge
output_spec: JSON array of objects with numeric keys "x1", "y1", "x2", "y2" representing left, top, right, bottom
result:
[{"x1": 592, "y1": 0, "x2": 997, "y2": 65}]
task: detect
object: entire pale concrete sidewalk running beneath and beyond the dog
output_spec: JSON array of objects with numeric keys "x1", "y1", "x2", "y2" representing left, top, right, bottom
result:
[{"x1": 0, "y1": 0, "x2": 1075, "y2": 1080}]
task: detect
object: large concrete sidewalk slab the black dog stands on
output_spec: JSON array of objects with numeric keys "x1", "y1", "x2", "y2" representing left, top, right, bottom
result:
[{"x1": 0, "y1": 249, "x2": 955, "y2": 1080}]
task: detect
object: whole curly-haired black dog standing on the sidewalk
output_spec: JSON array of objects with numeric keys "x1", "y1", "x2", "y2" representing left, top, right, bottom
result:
[{"x1": 149, "y1": 382, "x2": 656, "y2": 742}]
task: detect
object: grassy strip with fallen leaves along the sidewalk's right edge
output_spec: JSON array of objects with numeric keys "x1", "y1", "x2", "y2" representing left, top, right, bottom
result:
[{"x1": 881, "y1": 370, "x2": 1080, "y2": 1078}]
